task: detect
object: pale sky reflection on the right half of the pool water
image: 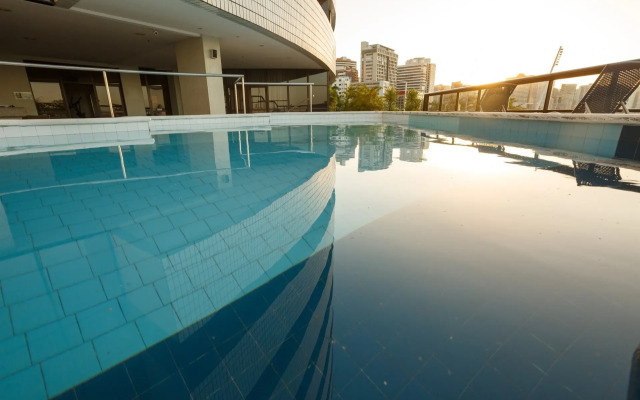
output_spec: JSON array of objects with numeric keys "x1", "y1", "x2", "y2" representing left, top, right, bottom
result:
[{"x1": 334, "y1": 130, "x2": 640, "y2": 399}]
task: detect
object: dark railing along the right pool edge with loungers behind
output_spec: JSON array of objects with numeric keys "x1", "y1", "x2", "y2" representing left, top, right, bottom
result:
[{"x1": 422, "y1": 60, "x2": 640, "y2": 113}]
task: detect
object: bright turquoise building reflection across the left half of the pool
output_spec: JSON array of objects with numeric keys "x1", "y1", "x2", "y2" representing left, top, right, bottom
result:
[{"x1": 0, "y1": 127, "x2": 335, "y2": 398}]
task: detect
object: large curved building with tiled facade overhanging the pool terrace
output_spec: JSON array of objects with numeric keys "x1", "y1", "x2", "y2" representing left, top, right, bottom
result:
[{"x1": 0, "y1": 0, "x2": 336, "y2": 118}]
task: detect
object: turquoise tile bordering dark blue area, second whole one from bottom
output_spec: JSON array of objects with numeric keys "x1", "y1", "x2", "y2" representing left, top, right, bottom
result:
[{"x1": 93, "y1": 323, "x2": 145, "y2": 369}]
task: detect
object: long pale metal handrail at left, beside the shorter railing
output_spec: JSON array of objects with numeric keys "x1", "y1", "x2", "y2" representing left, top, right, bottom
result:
[{"x1": 0, "y1": 61, "x2": 247, "y2": 118}]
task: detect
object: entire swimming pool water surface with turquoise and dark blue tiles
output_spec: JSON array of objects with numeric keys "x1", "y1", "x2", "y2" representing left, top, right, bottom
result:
[{"x1": 0, "y1": 125, "x2": 640, "y2": 399}]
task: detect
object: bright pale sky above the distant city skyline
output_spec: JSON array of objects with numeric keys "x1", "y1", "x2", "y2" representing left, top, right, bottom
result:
[{"x1": 335, "y1": 0, "x2": 640, "y2": 85}]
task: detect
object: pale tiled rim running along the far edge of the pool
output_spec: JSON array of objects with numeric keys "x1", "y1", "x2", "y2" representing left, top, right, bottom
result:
[{"x1": 0, "y1": 111, "x2": 640, "y2": 158}]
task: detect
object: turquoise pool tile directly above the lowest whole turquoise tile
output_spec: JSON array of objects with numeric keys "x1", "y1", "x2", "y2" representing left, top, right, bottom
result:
[{"x1": 27, "y1": 316, "x2": 82, "y2": 363}]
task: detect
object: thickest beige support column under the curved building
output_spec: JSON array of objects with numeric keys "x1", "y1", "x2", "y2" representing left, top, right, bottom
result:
[{"x1": 175, "y1": 36, "x2": 225, "y2": 115}]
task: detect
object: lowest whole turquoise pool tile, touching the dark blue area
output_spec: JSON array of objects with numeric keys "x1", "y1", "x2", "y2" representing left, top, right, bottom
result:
[{"x1": 42, "y1": 343, "x2": 100, "y2": 396}]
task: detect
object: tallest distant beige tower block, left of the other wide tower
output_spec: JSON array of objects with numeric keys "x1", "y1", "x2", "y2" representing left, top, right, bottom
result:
[{"x1": 360, "y1": 42, "x2": 398, "y2": 87}]
